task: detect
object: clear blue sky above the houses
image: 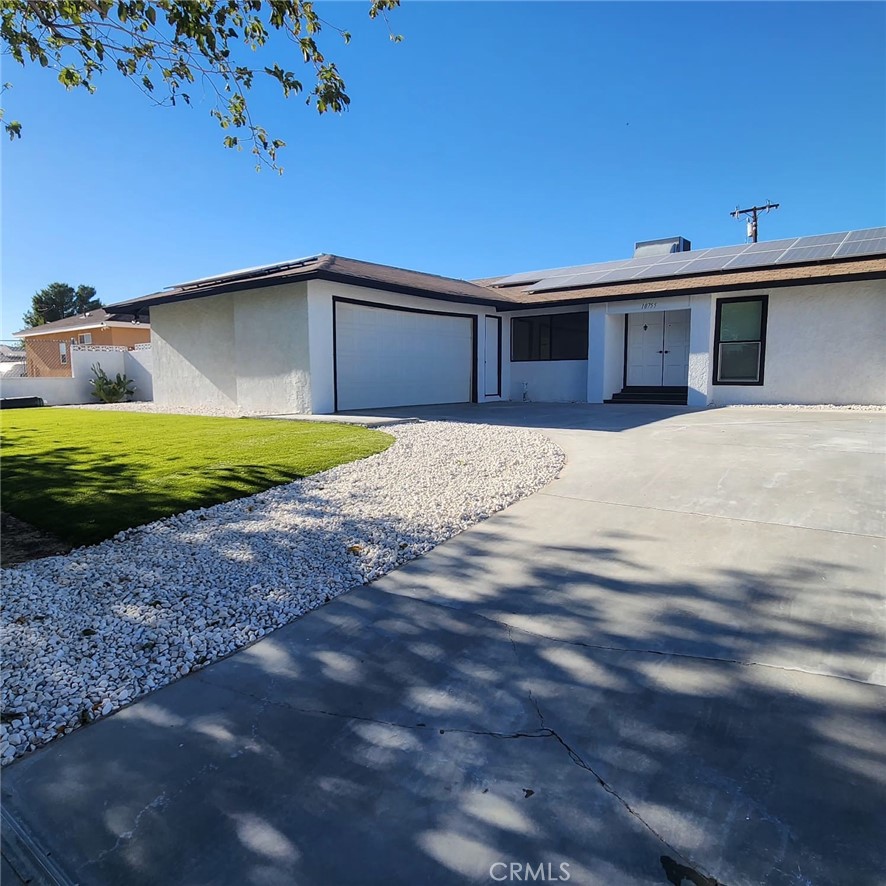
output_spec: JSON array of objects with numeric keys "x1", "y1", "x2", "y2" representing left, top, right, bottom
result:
[{"x1": 0, "y1": 0, "x2": 886, "y2": 339}]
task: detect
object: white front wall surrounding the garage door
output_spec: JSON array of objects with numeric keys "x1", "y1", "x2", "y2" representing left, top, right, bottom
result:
[{"x1": 307, "y1": 280, "x2": 507, "y2": 415}]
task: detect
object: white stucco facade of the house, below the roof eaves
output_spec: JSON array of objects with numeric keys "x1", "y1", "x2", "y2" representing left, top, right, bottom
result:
[{"x1": 137, "y1": 260, "x2": 886, "y2": 414}]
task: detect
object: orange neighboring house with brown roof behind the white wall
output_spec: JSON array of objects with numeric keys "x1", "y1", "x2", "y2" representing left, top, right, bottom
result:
[{"x1": 13, "y1": 308, "x2": 151, "y2": 378}]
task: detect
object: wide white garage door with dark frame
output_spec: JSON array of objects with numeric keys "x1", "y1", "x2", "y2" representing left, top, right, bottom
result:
[{"x1": 335, "y1": 301, "x2": 474, "y2": 409}]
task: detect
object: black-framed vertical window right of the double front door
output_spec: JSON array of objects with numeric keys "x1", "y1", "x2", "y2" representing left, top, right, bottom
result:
[{"x1": 714, "y1": 295, "x2": 769, "y2": 385}]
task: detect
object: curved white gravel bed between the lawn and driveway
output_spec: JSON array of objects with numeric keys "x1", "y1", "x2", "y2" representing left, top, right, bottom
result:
[{"x1": 0, "y1": 422, "x2": 564, "y2": 764}]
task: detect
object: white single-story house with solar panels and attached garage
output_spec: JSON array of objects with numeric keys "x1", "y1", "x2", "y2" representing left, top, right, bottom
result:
[{"x1": 112, "y1": 228, "x2": 886, "y2": 413}]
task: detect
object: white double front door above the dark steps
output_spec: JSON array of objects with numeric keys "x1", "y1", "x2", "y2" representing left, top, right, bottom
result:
[{"x1": 625, "y1": 311, "x2": 690, "y2": 387}]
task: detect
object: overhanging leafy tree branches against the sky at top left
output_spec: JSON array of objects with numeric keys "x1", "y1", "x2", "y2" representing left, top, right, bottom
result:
[{"x1": 0, "y1": 0, "x2": 402, "y2": 172}]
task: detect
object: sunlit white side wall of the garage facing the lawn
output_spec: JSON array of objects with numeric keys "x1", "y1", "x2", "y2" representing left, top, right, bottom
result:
[{"x1": 151, "y1": 283, "x2": 311, "y2": 413}]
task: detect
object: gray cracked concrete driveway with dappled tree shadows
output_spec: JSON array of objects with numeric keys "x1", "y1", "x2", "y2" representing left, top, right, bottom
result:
[{"x1": 2, "y1": 404, "x2": 886, "y2": 886}]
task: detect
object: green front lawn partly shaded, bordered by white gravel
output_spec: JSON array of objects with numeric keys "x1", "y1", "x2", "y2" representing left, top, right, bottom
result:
[{"x1": 0, "y1": 408, "x2": 393, "y2": 545}]
